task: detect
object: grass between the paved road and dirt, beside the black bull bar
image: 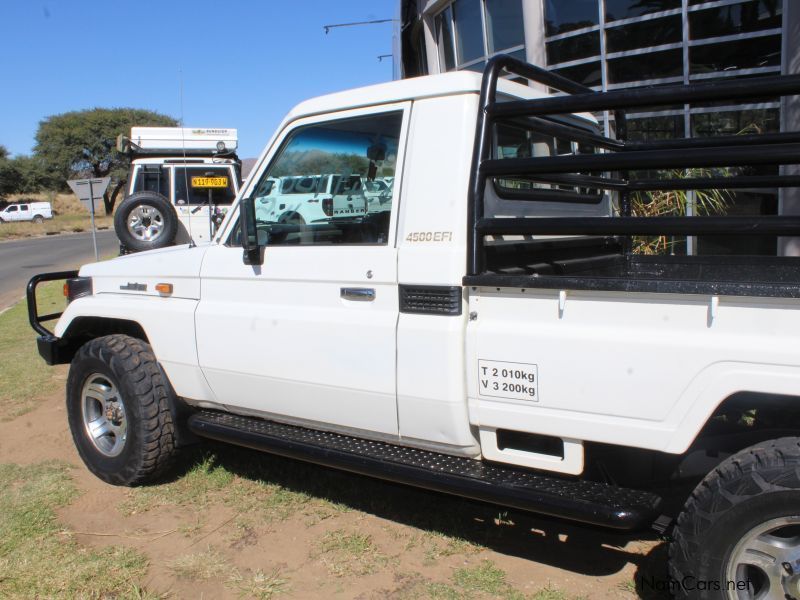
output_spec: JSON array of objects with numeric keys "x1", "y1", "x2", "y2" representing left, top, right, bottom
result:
[{"x1": 0, "y1": 282, "x2": 66, "y2": 421}]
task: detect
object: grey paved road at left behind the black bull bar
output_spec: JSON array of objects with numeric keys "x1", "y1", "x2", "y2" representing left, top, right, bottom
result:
[{"x1": 0, "y1": 231, "x2": 119, "y2": 310}]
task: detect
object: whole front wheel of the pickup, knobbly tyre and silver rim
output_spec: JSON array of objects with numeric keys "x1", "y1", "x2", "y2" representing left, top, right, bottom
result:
[{"x1": 67, "y1": 335, "x2": 176, "y2": 486}]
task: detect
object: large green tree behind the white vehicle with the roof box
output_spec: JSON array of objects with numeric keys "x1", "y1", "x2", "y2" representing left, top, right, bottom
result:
[{"x1": 34, "y1": 108, "x2": 178, "y2": 214}]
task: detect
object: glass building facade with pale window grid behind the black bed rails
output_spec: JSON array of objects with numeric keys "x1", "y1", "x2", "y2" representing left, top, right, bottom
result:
[{"x1": 401, "y1": 0, "x2": 800, "y2": 254}]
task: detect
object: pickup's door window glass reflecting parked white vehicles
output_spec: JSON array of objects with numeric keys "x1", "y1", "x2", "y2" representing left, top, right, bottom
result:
[{"x1": 247, "y1": 111, "x2": 403, "y2": 246}]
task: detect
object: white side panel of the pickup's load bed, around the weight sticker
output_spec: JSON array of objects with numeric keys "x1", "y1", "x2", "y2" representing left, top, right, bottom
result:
[{"x1": 467, "y1": 288, "x2": 800, "y2": 453}]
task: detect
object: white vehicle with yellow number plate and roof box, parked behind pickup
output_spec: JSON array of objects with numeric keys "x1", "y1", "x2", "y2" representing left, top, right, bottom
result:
[{"x1": 114, "y1": 127, "x2": 241, "y2": 253}]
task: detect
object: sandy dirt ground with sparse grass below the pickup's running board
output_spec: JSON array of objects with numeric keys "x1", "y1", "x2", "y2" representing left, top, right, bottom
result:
[{"x1": 0, "y1": 393, "x2": 665, "y2": 600}]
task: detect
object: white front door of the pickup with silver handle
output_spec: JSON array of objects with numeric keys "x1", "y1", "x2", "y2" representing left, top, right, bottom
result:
[{"x1": 196, "y1": 103, "x2": 410, "y2": 437}]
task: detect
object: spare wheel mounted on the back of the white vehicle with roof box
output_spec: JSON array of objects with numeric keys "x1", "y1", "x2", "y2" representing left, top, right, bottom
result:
[{"x1": 114, "y1": 192, "x2": 178, "y2": 252}]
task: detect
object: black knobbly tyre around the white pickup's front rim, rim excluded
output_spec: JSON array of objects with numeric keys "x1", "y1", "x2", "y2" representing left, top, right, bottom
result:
[{"x1": 67, "y1": 334, "x2": 177, "y2": 486}]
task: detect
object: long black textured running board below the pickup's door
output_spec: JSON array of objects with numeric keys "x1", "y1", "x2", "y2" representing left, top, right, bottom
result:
[{"x1": 189, "y1": 410, "x2": 661, "y2": 530}]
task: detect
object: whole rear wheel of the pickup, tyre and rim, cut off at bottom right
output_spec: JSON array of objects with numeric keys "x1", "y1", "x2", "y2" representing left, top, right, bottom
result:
[{"x1": 669, "y1": 438, "x2": 800, "y2": 600}]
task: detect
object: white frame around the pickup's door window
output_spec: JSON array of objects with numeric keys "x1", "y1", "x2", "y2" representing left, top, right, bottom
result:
[{"x1": 225, "y1": 100, "x2": 412, "y2": 249}]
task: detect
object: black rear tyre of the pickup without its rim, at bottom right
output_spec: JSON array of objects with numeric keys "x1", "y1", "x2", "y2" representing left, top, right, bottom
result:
[{"x1": 669, "y1": 437, "x2": 800, "y2": 600}]
